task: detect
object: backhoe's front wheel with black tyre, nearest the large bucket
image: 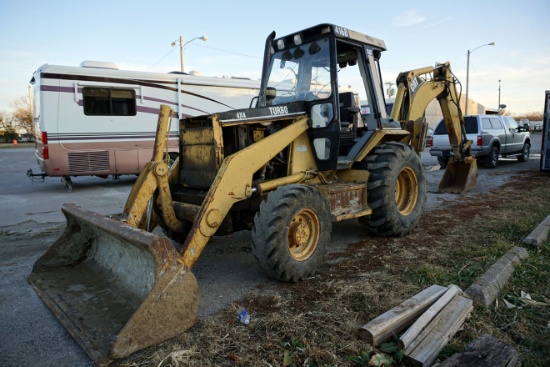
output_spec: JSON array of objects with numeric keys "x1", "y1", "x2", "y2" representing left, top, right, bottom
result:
[{"x1": 252, "y1": 184, "x2": 332, "y2": 282}]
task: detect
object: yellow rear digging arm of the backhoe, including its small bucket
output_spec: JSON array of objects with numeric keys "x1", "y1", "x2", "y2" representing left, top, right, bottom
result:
[{"x1": 391, "y1": 62, "x2": 477, "y2": 193}]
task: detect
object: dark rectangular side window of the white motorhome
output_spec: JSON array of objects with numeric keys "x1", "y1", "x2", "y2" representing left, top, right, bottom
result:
[{"x1": 82, "y1": 88, "x2": 136, "y2": 116}]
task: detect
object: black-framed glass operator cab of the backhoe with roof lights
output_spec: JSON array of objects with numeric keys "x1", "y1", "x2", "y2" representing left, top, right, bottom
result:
[{"x1": 258, "y1": 24, "x2": 394, "y2": 170}]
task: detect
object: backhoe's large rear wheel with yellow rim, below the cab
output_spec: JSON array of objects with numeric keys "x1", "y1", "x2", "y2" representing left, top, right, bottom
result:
[{"x1": 359, "y1": 142, "x2": 426, "y2": 236}]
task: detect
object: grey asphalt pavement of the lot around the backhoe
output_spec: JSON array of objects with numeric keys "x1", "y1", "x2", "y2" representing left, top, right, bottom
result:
[{"x1": 0, "y1": 134, "x2": 541, "y2": 366}]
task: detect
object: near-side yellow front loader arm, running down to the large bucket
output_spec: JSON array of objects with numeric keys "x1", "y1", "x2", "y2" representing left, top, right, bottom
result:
[{"x1": 182, "y1": 115, "x2": 309, "y2": 269}]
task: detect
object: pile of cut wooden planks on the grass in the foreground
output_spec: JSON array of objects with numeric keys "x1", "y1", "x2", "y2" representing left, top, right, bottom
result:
[{"x1": 359, "y1": 285, "x2": 473, "y2": 366}]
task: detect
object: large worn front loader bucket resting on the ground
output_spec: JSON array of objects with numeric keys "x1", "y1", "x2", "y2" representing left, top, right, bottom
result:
[{"x1": 29, "y1": 204, "x2": 198, "y2": 365}]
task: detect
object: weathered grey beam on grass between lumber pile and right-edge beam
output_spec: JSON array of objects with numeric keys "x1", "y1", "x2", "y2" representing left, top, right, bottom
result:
[{"x1": 465, "y1": 246, "x2": 529, "y2": 307}]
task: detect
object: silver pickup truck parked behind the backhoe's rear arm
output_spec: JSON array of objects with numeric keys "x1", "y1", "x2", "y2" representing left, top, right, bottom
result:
[{"x1": 428, "y1": 115, "x2": 531, "y2": 168}]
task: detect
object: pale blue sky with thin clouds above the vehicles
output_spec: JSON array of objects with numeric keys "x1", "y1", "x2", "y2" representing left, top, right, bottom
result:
[{"x1": 0, "y1": 0, "x2": 550, "y2": 114}]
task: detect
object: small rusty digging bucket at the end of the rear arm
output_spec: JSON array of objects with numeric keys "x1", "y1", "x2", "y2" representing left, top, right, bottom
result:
[{"x1": 439, "y1": 158, "x2": 477, "y2": 194}]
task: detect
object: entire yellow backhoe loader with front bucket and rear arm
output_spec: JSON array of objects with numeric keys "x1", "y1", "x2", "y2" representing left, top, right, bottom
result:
[{"x1": 29, "y1": 24, "x2": 477, "y2": 364}]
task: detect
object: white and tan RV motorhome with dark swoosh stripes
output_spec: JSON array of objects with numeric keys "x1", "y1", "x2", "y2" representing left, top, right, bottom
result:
[{"x1": 30, "y1": 61, "x2": 260, "y2": 190}]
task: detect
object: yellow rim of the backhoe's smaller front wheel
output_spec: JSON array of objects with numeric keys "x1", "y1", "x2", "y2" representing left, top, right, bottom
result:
[{"x1": 288, "y1": 209, "x2": 321, "y2": 261}]
